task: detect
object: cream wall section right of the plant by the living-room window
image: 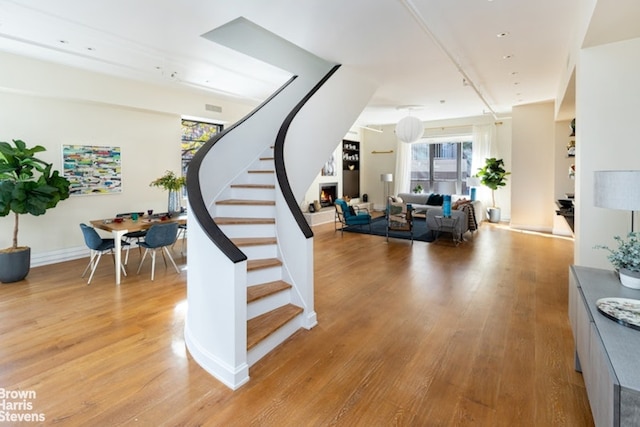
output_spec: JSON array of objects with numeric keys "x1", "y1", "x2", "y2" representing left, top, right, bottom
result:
[{"x1": 505, "y1": 102, "x2": 555, "y2": 232}]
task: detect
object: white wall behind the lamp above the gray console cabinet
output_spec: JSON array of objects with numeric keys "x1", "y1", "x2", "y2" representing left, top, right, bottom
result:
[{"x1": 575, "y1": 38, "x2": 640, "y2": 269}]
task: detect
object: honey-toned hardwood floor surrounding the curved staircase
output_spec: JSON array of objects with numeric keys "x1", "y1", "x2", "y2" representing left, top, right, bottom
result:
[{"x1": 0, "y1": 224, "x2": 593, "y2": 426}]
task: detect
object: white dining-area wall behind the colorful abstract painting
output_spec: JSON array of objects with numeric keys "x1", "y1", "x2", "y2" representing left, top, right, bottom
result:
[{"x1": 0, "y1": 54, "x2": 252, "y2": 266}]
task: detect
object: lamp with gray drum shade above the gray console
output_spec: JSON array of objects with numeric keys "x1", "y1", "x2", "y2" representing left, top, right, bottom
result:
[{"x1": 593, "y1": 171, "x2": 640, "y2": 232}]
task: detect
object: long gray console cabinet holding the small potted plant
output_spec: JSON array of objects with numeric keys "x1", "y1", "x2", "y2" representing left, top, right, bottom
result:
[{"x1": 569, "y1": 266, "x2": 640, "y2": 426}]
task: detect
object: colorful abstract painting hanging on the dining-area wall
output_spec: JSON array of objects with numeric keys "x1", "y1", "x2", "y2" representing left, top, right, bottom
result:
[{"x1": 62, "y1": 145, "x2": 122, "y2": 196}]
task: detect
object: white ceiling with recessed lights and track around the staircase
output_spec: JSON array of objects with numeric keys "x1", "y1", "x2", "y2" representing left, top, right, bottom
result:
[{"x1": 0, "y1": 0, "x2": 616, "y2": 125}]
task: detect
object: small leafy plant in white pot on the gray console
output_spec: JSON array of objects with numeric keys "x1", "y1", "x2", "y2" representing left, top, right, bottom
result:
[{"x1": 595, "y1": 232, "x2": 640, "y2": 289}]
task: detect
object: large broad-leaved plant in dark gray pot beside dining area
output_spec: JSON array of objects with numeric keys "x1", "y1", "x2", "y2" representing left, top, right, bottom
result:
[{"x1": 0, "y1": 139, "x2": 69, "y2": 283}]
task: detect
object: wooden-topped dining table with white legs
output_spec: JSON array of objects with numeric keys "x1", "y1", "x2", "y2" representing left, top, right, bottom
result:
[{"x1": 90, "y1": 213, "x2": 187, "y2": 285}]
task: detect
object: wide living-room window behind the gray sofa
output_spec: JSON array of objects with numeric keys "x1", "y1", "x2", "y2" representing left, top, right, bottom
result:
[{"x1": 409, "y1": 137, "x2": 473, "y2": 194}]
